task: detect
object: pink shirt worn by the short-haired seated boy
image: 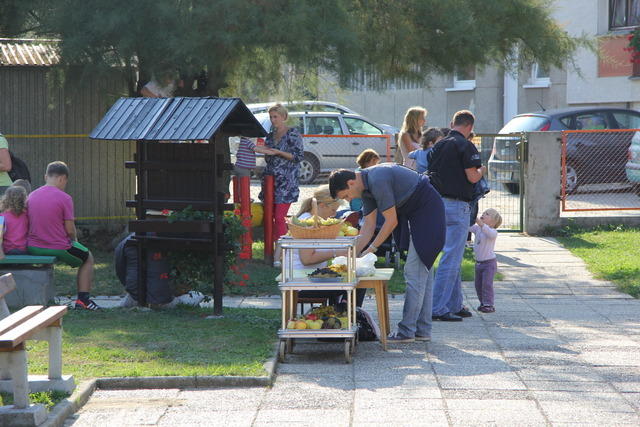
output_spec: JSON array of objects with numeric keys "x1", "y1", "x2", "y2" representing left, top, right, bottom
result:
[{"x1": 27, "y1": 185, "x2": 74, "y2": 249}]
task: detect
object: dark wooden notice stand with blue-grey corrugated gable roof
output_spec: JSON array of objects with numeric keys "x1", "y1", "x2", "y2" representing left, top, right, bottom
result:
[{"x1": 90, "y1": 98, "x2": 266, "y2": 314}]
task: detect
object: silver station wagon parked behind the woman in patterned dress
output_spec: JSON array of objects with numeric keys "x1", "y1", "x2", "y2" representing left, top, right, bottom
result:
[{"x1": 255, "y1": 112, "x2": 395, "y2": 184}]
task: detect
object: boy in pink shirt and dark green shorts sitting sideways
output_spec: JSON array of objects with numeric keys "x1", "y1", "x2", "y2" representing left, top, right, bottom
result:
[{"x1": 27, "y1": 161, "x2": 99, "y2": 310}]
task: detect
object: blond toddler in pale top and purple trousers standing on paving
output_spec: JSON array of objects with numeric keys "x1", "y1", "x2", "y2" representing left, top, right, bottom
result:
[{"x1": 469, "y1": 209, "x2": 502, "y2": 313}]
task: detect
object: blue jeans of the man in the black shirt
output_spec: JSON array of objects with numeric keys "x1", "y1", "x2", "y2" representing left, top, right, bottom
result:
[{"x1": 433, "y1": 198, "x2": 471, "y2": 316}]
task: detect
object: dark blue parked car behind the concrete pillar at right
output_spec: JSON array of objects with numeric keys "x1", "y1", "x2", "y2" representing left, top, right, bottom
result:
[{"x1": 489, "y1": 107, "x2": 640, "y2": 194}]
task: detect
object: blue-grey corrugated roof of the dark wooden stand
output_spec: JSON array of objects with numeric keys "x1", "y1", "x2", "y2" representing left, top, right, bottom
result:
[{"x1": 89, "y1": 98, "x2": 266, "y2": 141}]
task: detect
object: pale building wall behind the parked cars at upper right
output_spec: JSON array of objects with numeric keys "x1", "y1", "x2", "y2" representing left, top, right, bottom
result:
[{"x1": 319, "y1": 0, "x2": 640, "y2": 133}]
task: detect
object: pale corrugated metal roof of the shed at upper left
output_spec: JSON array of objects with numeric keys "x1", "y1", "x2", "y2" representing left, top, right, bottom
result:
[{"x1": 0, "y1": 38, "x2": 60, "y2": 67}]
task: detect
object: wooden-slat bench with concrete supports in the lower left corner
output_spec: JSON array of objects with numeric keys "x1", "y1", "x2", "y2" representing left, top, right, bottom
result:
[{"x1": 0, "y1": 274, "x2": 75, "y2": 425}]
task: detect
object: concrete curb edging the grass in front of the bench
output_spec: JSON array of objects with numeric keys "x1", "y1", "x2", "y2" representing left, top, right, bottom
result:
[{"x1": 38, "y1": 342, "x2": 278, "y2": 427}]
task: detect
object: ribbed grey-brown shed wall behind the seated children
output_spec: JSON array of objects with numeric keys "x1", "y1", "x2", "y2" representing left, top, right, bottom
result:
[{"x1": 0, "y1": 67, "x2": 135, "y2": 227}]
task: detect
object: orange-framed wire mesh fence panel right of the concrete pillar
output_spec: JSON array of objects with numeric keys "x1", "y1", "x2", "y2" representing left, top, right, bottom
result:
[{"x1": 561, "y1": 129, "x2": 640, "y2": 212}]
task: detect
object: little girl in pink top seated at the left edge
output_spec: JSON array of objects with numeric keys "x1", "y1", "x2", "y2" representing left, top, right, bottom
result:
[{"x1": 0, "y1": 185, "x2": 29, "y2": 255}]
